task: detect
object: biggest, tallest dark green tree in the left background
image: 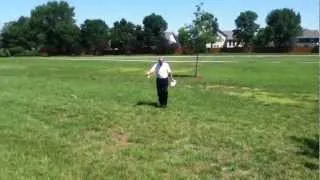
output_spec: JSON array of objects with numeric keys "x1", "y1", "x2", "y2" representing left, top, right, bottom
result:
[{"x1": 30, "y1": 1, "x2": 80, "y2": 53}]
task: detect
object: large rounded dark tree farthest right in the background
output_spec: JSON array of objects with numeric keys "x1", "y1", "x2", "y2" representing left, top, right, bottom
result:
[{"x1": 266, "y1": 8, "x2": 302, "y2": 48}]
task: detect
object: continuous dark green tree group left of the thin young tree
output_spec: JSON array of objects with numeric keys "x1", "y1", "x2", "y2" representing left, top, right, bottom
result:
[{"x1": 0, "y1": 1, "x2": 173, "y2": 55}]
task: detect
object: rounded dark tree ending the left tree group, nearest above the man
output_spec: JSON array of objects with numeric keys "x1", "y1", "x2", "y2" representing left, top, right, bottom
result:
[{"x1": 143, "y1": 13, "x2": 168, "y2": 47}]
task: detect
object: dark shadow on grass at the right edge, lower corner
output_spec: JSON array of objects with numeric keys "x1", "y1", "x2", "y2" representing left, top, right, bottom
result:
[{"x1": 291, "y1": 135, "x2": 319, "y2": 170}]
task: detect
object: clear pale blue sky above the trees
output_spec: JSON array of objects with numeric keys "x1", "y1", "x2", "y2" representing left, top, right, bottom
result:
[{"x1": 0, "y1": 0, "x2": 319, "y2": 32}]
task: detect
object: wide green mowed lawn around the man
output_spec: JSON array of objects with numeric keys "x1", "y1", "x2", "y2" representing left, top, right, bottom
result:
[{"x1": 0, "y1": 56, "x2": 319, "y2": 180}]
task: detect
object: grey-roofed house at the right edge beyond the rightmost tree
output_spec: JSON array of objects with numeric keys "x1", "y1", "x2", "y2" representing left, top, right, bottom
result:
[{"x1": 296, "y1": 29, "x2": 319, "y2": 47}]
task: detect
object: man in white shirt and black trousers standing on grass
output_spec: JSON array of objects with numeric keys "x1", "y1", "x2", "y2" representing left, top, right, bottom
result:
[{"x1": 147, "y1": 57, "x2": 173, "y2": 108}]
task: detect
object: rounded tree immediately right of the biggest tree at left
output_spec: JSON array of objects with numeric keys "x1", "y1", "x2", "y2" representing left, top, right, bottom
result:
[{"x1": 81, "y1": 19, "x2": 109, "y2": 53}]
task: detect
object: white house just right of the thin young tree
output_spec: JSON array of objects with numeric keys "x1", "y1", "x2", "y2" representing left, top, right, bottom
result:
[{"x1": 206, "y1": 30, "x2": 243, "y2": 48}]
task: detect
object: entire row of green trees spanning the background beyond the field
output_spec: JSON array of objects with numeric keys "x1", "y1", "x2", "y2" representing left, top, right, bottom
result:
[{"x1": 0, "y1": 1, "x2": 302, "y2": 56}]
